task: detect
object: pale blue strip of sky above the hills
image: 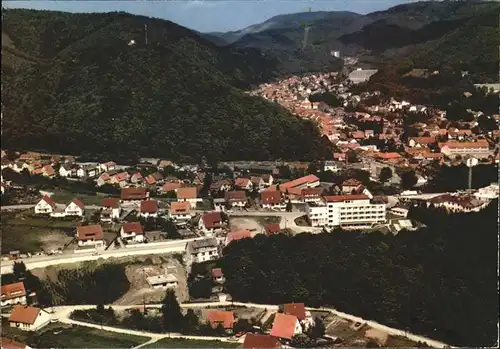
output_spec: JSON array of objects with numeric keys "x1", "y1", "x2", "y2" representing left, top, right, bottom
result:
[{"x1": 2, "y1": 0, "x2": 413, "y2": 32}]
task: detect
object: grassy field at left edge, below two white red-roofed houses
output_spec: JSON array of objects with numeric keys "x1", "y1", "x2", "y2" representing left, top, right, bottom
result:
[{"x1": 0, "y1": 211, "x2": 77, "y2": 254}]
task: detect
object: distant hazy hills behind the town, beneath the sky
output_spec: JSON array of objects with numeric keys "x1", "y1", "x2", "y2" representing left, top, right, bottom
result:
[{"x1": 204, "y1": 1, "x2": 498, "y2": 73}]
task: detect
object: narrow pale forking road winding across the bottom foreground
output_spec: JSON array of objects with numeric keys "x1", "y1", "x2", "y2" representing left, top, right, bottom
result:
[{"x1": 48, "y1": 301, "x2": 453, "y2": 348}]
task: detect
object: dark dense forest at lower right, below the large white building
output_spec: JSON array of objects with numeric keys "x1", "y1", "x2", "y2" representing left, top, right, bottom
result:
[{"x1": 222, "y1": 200, "x2": 498, "y2": 347}]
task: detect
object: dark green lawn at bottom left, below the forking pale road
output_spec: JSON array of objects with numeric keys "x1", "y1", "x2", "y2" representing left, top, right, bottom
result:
[{"x1": 33, "y1": 326, "x2": 149, "y2": 348}]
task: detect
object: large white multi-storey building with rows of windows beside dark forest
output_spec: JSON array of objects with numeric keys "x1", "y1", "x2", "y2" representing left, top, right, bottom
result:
[{"x1": 306, "y1": 194, "x2": 386, "y2": 229}]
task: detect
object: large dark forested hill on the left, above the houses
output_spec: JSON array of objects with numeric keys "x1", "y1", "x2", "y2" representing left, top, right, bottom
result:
[{"x1": 2, "y1": 9, "x2": 328, "y2": 160}]
